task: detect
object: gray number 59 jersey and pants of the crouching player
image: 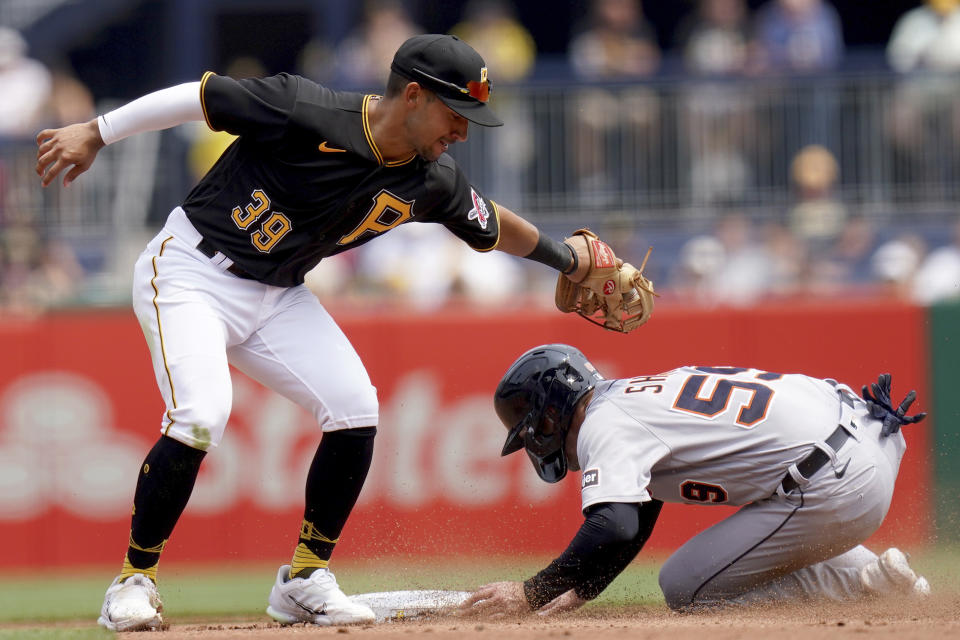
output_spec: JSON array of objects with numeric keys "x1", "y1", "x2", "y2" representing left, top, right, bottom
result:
[{"x1": 577, "y1": 367, "x2": 906, "y2": 608}]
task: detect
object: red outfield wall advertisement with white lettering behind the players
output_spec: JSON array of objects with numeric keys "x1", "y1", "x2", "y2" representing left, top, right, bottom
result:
[{"x1": 0, "y1": 302, "x2": 930, "y2": 568}]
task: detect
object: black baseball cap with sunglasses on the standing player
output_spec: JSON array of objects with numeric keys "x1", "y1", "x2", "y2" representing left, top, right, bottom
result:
[{"x1": 390, "y1": 33, "x2": 503, "y2": 127}]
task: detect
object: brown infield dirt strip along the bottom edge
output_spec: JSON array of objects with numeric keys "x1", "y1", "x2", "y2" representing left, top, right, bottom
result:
[{"x1": 127, "y1": 595, "x2": 960, "y2": 640}]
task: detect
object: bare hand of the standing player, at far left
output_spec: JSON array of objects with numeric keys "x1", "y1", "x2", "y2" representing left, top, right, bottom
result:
[{"x1": 37, "y1": 119, "x2": 104, "y2": 187}]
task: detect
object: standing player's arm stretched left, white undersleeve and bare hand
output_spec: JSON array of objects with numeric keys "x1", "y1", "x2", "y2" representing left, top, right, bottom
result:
[{"x1": 36, "y1": 82, "x2": 203, "y2": 187}]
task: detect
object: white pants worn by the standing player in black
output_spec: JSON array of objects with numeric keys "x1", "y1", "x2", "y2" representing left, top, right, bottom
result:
[{"x1": 133, "y1": 207, "x2": 378, "y2": 450}]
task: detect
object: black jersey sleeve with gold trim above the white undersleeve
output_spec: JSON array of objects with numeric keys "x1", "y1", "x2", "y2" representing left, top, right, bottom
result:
[{"x1": 200, "y1": 72, "x2": 299, "y2": 142}]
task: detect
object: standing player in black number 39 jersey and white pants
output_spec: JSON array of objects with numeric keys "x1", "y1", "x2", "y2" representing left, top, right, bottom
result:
[{"x1": 37, "y1": 34, "x2": 644, "y2": 631}]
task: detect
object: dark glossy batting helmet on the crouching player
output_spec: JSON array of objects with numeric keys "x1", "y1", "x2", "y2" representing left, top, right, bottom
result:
[{"x1": 493, "y1": 344, "x2": 603, "y2": 482}]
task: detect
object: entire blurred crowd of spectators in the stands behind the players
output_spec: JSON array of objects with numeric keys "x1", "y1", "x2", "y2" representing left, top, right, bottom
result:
[{"x1": 0, "y1": 0, "x2": 960, "y2": 314}]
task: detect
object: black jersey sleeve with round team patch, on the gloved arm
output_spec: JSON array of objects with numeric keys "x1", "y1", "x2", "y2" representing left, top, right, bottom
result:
[{"x1": 425, "y1": 156, "x2": 500, "y2": 251}]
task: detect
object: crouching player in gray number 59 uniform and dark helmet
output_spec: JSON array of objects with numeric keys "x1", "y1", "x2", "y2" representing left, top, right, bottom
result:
[{"x1": 463, "y1": 344, "x2": 930, "y2": 615}]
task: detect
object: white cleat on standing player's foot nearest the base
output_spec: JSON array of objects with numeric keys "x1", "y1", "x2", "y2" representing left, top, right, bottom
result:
[{"x1": 267, "y1": 564, "x2": 376, "y2": 627}]
